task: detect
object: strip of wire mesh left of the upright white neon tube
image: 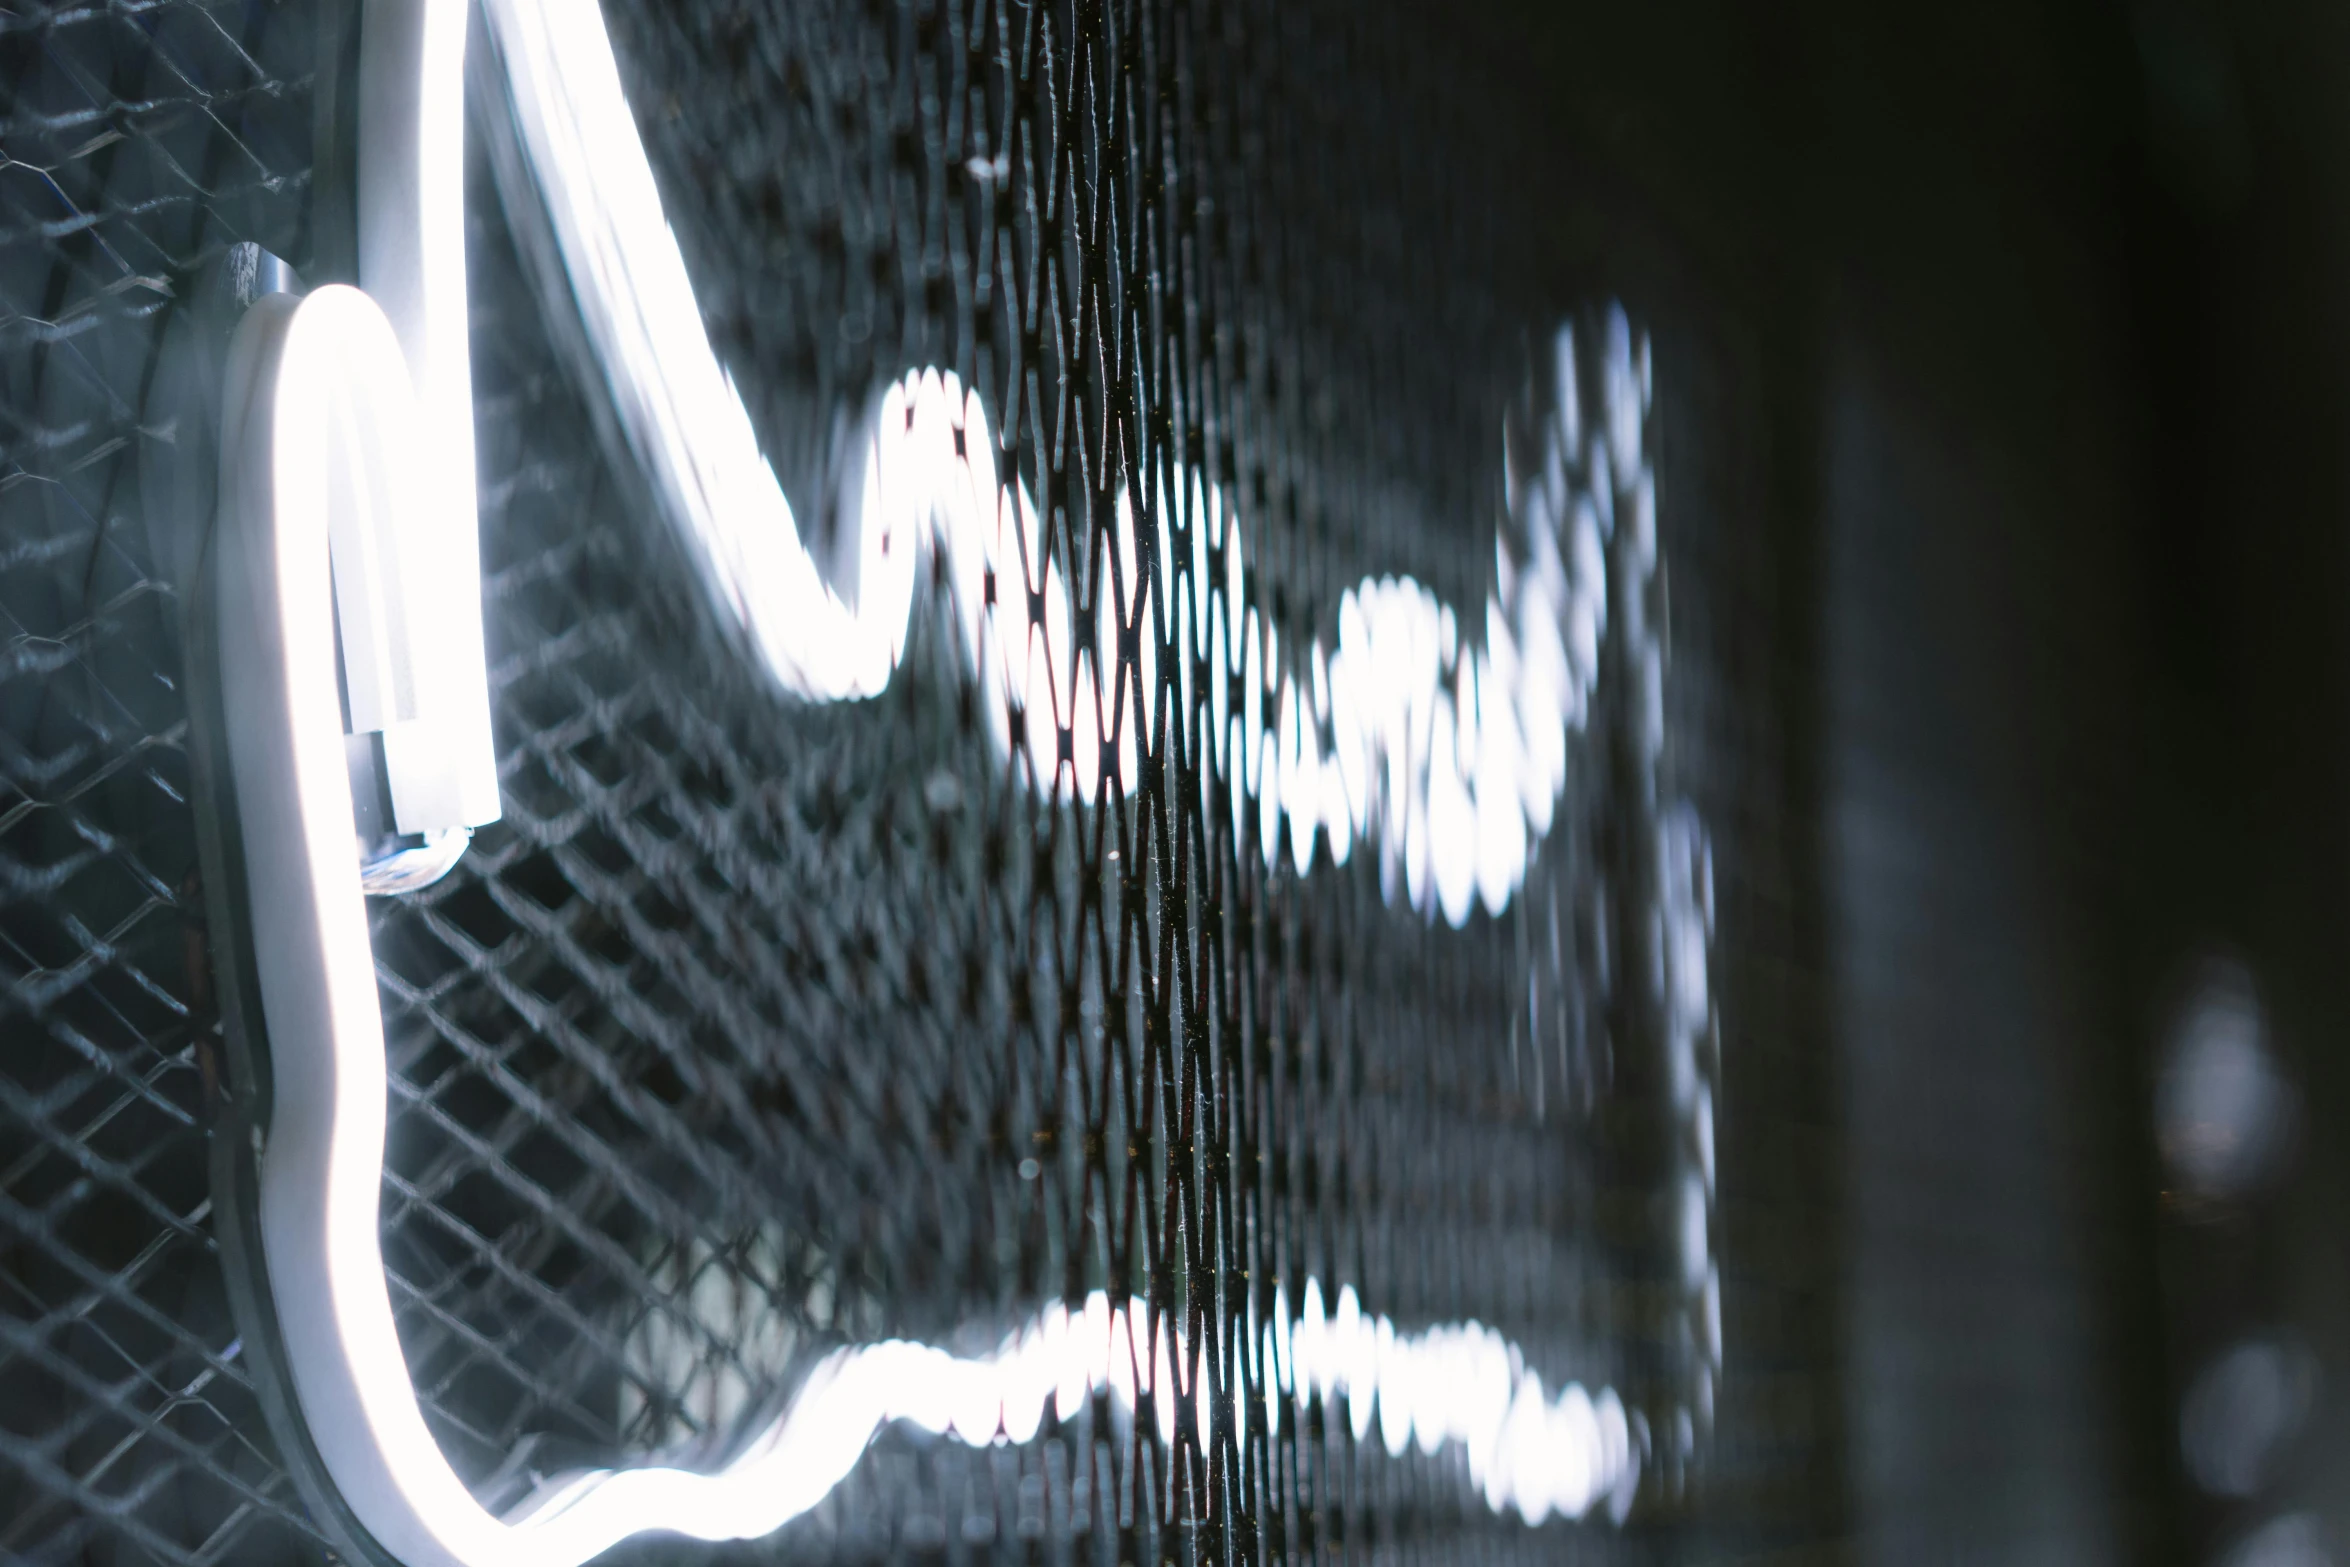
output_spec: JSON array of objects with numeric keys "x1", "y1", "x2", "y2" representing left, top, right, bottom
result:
[{"x1": 0, "y1": 5, "x2": 315, "y2": 1562}]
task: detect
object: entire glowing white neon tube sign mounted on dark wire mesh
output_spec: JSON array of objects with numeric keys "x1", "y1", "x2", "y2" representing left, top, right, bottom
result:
[{"x1": 216, "y1": 0, "x2": 1720, "y2": 1567}]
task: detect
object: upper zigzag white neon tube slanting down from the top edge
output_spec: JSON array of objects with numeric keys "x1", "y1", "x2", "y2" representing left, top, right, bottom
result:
[{"x1": 472, "y1": 0, "x2": 1657, "y2": 926}]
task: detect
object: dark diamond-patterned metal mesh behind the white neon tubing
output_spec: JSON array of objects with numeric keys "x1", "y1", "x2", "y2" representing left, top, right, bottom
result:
[{"x1": 0, "y1": 0, "x2": 1781, "y2": 1562}]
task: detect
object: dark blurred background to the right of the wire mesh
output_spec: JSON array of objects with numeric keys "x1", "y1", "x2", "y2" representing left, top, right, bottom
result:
[{"x1": 1492, "y1": 0, "x2": 2350, "y2": 1562}]
